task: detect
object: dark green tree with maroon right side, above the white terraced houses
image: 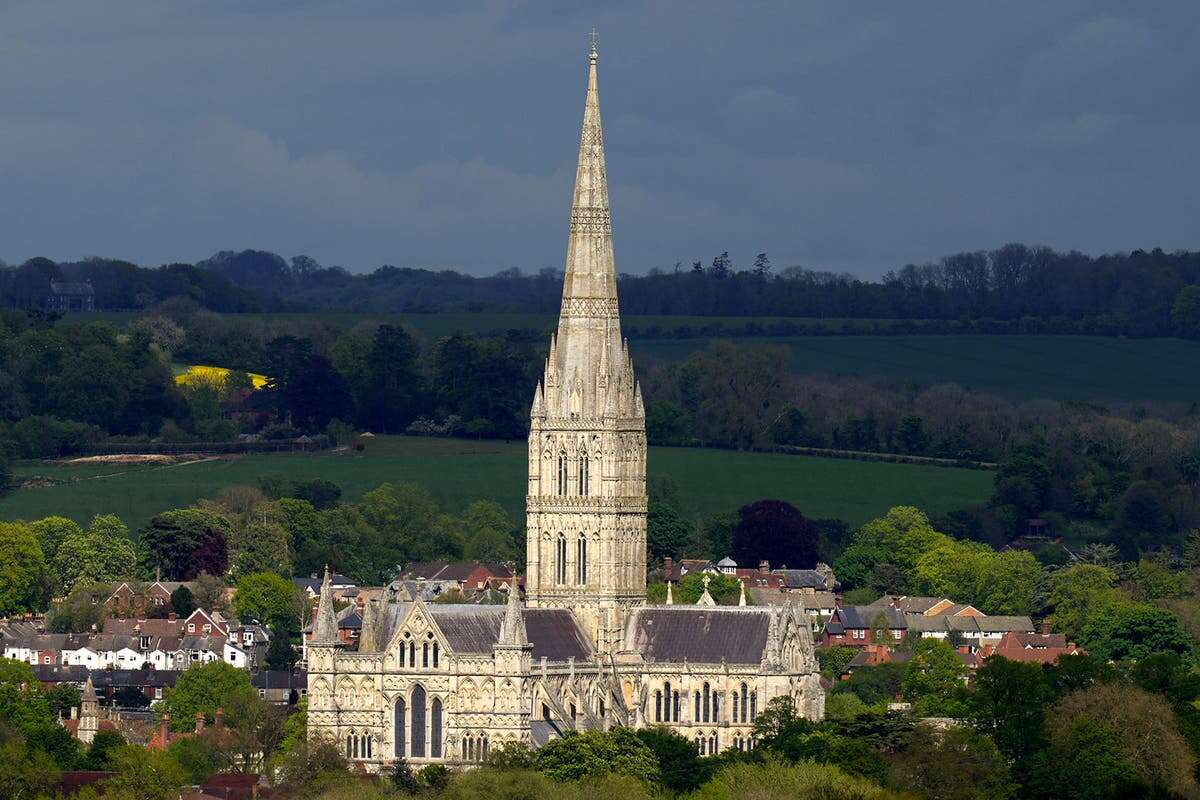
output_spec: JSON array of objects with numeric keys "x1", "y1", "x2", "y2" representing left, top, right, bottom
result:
[{"x1": 140, "y1": 509, "x2": 232, "y2": 581}]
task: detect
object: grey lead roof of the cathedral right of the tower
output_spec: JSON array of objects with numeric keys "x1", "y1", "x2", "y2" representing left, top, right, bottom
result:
[{"x1": 626, "y1": 606, "x2": 770, "y2": 664}]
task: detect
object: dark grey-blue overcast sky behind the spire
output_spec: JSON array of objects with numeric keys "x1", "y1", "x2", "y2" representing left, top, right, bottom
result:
[{"x1": 0, "y1": 0, "x2": 1200, "y2": 277}]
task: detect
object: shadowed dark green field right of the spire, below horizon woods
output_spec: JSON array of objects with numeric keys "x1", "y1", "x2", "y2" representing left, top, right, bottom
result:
[{"x1": 630, "y1": 335, "x2": 1200, "y2": 404}]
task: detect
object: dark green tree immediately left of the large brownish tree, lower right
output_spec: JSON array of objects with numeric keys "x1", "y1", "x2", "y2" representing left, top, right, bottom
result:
[{"x1": 970, "y1": 656, "x2": 1052, "y2": 759}]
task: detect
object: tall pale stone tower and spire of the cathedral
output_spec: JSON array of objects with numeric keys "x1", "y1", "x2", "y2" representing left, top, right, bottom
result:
[{"x1": 526, "y1": 42, "x2": 646, "y2": 652}]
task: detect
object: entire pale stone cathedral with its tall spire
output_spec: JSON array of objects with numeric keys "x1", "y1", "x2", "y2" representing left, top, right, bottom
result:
[{"x1": 307, "y1": 46, "x2": 824, "y2": 771}]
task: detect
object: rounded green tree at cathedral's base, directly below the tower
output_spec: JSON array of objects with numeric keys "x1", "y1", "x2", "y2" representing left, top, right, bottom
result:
[{"x1": 535, "y1": 728, "x2": 661, "y2": 783}]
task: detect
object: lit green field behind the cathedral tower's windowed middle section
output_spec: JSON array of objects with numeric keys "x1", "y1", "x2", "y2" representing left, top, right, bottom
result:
[{"x1": 0, "y1": 437, "x2": 992, "y2": 530}]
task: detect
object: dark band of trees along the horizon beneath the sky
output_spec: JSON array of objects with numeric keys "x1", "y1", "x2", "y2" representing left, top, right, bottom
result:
[{"x1": 7, "y1": 243, "x2": 1200, "y2": 336}]
